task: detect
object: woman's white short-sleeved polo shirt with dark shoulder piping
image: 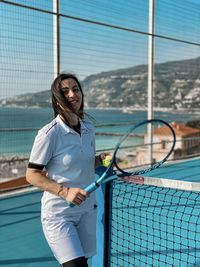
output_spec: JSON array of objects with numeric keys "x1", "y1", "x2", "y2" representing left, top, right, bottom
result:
[{"x1": 29, "y1": 116, "x2": 96, "y2": 217}]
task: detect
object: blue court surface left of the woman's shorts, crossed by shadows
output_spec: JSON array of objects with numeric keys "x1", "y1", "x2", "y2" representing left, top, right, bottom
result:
[{"x1": 0, "y1": 191, "x2": 59, "y2": 267}]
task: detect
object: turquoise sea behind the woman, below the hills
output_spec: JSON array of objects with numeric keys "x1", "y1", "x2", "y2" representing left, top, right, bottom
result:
[{"x1": 0, "y1": 107, "x2": 200, "y2": 157}]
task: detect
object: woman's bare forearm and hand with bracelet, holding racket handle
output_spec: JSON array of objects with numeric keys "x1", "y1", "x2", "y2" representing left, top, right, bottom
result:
[{"x1": 26, "y1": 168, "x2": 89, "y2": 205}]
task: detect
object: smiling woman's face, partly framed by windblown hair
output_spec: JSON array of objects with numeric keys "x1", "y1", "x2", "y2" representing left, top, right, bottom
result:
[{"x1": 61, "y1": 78, "x2": 83, "y2": 112}]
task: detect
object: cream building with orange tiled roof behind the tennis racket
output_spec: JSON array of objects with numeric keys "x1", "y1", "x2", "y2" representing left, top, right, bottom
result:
[{"x1": 136, "y1": 122, "x2": 200, "y2": 165}]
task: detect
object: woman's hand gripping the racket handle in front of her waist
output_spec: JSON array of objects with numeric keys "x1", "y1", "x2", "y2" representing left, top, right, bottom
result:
[{"x1": 60, "y1": 187, "x2": 89, "y2": 205}]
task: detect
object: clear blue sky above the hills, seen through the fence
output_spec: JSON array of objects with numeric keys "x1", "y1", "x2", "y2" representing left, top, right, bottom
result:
[{"x1": 0, "y1": 0, "x2": 200, "y2": 99}]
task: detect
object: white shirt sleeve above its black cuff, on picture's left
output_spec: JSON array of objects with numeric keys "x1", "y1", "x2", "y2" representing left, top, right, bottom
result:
[{"x1": 29, "y1": 131, "x2": 54, "y2": 166}]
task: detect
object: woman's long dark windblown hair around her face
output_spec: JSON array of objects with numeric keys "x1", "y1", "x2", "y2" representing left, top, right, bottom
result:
[{"x1": 51, "y1": 73, "x2": 84, "y2": 125}]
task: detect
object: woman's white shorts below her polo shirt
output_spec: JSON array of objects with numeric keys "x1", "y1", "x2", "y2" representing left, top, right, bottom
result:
[{"x1": 42, "y1": 208, "x2": 97, "y2": 264}]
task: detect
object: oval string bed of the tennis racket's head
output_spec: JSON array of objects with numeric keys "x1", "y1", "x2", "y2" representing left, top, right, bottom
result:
[{"x1": 115, "y1": 120, "x2": 175, "y2": 175}]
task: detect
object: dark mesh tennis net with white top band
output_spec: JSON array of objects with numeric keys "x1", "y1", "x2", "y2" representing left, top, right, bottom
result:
[{"x1": 104, "y1": 177, "x2": 200, "y2": 267}]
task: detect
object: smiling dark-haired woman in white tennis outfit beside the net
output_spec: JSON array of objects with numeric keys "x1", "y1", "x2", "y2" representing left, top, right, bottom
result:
[{"x1": 26, "y1": 74, "x2": 105, "y2": 267}]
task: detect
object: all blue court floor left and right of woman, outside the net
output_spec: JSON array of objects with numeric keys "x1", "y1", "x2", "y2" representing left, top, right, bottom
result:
[{"x1": 0, "y1": 159, "x2": 200, "y2": 267}]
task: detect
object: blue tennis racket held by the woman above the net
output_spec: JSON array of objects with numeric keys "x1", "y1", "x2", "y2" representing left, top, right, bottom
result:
[{"x1": 70, "y1": 119, "x2": 176, "y2": 207}]
